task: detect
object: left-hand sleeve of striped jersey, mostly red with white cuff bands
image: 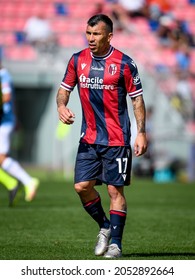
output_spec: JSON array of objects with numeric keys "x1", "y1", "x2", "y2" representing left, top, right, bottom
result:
[{"x1": 60, "y1": 55, "x2": 77, "y2": 91}]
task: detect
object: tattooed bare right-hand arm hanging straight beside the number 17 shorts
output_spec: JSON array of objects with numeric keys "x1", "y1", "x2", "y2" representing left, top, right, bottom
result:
[{"x1": 132, "y1": 95, "x2": 147, "y2": 157}]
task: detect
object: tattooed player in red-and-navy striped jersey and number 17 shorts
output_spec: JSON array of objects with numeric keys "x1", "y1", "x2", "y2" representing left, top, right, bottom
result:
[{"x1": 56, "y1": 14, "x2": 147, "y2": 258}]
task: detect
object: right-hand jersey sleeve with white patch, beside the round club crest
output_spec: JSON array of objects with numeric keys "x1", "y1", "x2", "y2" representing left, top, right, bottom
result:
[{"x1": 124, "y1": 59, "x2": 143, "y2": 98}]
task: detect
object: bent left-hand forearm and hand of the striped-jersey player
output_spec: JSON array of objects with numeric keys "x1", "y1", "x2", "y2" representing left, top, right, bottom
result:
[{"x1": 56, "y1": 88, "x2": 75, "y2": 124}]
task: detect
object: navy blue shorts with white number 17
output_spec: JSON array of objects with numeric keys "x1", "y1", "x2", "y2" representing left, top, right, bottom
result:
[{"x1": 74, "y1": 143, "x2": 132, "y2": 187}]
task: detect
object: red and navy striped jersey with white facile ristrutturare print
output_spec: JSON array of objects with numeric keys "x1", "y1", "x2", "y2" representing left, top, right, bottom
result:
[{"x1": 61, "y1": 46, "x2": 143, "y2": 146}]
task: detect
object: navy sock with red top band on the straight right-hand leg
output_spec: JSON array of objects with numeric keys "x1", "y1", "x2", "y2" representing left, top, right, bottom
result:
[{"x1": 110, "y1": 210, "x2": 127, "y2": 249}]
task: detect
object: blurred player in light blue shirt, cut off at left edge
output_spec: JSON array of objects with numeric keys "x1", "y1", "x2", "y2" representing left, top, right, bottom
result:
[{"x1": 0, "y1": 61, "x2": 39, "y2": 205}]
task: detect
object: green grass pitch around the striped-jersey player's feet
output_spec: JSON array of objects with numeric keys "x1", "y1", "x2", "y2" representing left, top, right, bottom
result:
[{"x1": 0, "y1": 178, "x2": 195, "y2": 260}]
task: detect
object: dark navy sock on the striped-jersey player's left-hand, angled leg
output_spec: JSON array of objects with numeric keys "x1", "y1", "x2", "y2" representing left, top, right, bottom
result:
[{"x1": 83, "y1": 196, "x2": 110, "y2": 228}]
